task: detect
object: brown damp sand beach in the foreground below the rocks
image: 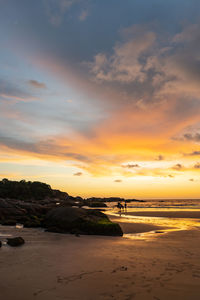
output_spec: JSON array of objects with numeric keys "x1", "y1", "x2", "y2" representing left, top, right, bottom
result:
[{"x1": 0, "y1": 219, "x2": 200, "y2": 300}]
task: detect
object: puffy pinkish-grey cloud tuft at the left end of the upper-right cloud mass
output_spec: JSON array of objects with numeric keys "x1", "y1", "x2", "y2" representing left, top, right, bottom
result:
[{"x1": 89, "y1": 26, "x2": 156, "y2": 84}]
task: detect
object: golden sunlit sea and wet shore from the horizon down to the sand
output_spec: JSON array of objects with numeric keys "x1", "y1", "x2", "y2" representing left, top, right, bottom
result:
[{"x1": 106, "y1": 199, "x2": 200, "y2": 240}]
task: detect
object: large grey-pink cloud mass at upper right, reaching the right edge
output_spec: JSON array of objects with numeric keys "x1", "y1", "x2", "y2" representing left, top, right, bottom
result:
[{"x1": 87, "y1": 25, "x2": 200, "y2": 115}]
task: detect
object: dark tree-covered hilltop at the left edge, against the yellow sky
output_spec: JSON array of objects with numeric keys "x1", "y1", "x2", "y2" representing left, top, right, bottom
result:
[{"x1": 0, "y1": 178, "x2": 55, "y2": 200}]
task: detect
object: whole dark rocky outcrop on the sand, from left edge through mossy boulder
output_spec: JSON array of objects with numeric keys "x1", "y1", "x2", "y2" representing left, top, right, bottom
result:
[{"x1": 0, "y1": 198, "x2": 123, "y2": 236}]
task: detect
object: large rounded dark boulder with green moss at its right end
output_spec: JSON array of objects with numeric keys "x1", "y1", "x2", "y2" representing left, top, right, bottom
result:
[{"x1": 44, "y1": 207, "x2": 123, "y2": 236}]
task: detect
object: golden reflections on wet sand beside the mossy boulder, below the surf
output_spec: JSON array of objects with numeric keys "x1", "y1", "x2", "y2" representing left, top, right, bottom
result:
[{"x1": 107, "y1": 208, "x2": 200, "y2": 240}]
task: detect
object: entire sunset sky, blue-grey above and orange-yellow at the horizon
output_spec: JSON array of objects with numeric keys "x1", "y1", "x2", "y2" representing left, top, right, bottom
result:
[{"x1": 0, "y1": 0, "x2": 200, "y2": 199}]
